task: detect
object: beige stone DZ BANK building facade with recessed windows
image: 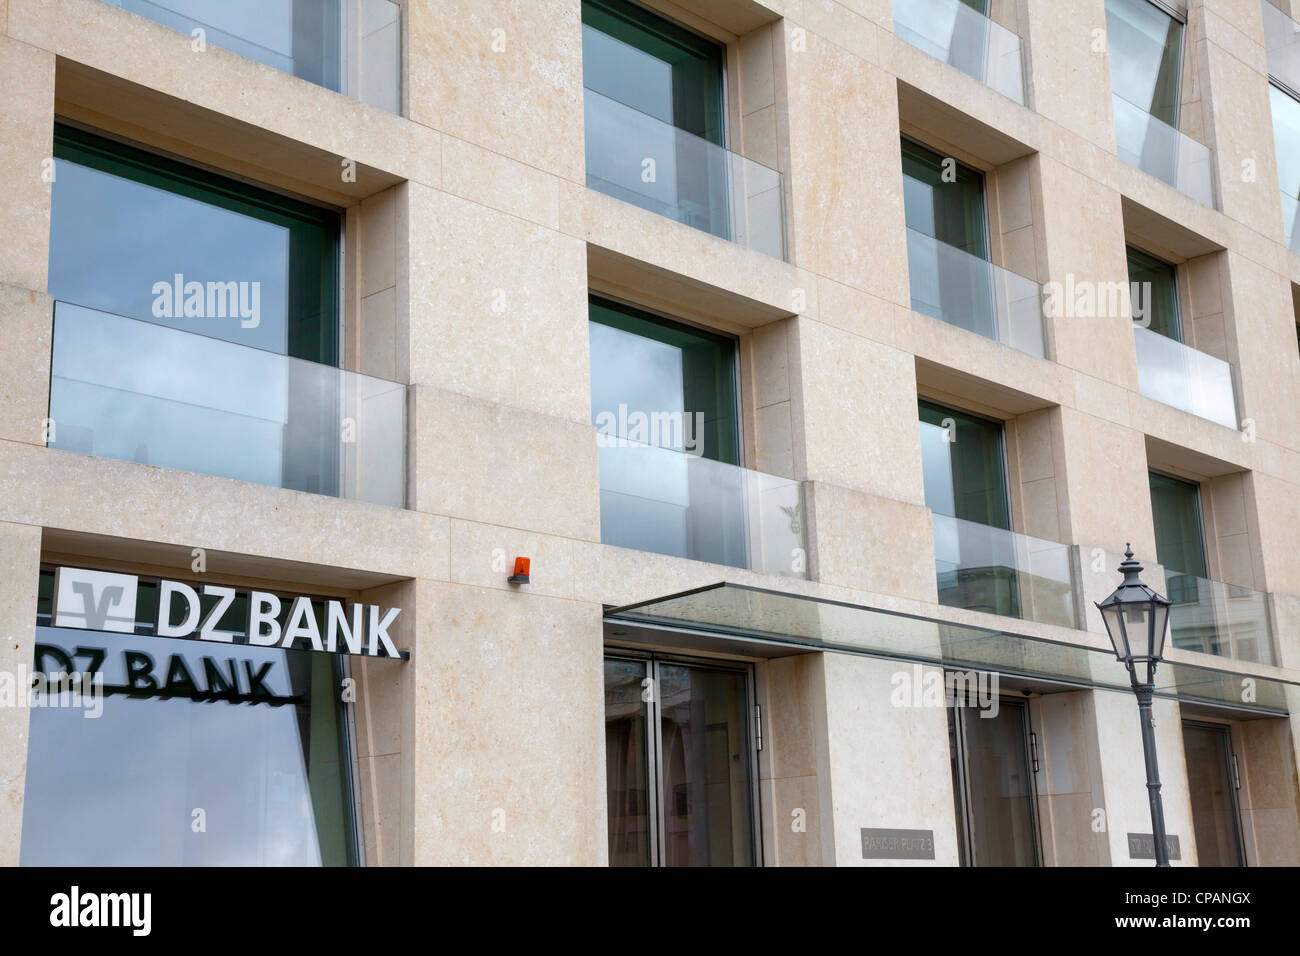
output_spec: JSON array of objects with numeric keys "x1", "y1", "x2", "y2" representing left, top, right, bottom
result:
[{"x1": 0, "y1": 0, "x2": 1300, "y2": 866}]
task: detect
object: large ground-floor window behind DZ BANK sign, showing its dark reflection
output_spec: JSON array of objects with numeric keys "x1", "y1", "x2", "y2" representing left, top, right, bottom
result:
[{"x1": 21, "y1": 570, "x2": 356, "y2": 866}]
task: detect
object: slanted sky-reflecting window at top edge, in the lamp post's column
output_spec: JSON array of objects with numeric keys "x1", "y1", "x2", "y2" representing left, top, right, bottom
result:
[{"x1": 1106, "y1": 0, "x2": 1183, "y2": 129}]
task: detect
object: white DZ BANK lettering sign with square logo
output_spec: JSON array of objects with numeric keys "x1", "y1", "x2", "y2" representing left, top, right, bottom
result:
[{"x1": 52, "y1": 567, "x2": 408, "y2": 659}]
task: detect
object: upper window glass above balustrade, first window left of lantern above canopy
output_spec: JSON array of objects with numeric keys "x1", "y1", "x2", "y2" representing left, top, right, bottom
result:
[{"x1": 919, "y1": 401, "x2": 1011, "y2": 529}]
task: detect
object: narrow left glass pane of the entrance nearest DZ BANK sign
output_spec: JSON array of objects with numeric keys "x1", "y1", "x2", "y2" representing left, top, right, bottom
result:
[{"x1": 605, "y1": 659, "x2": 650, "y2": 866}]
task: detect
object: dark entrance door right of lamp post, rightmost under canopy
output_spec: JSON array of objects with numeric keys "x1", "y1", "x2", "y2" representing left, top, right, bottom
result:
[{"x1": 1183, "y1": 721, "x2": 1245, "y2": 866}]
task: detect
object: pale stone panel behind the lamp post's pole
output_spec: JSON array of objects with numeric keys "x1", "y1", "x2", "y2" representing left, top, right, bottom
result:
[{"x1": 1091, "y1": 691, "x2": 1196, "y2": 866}]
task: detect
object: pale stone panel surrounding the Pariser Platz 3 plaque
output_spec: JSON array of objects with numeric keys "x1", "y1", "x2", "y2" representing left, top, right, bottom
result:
[{"x1": 824, "y1": 654, "x2": 958, "y2": 866}]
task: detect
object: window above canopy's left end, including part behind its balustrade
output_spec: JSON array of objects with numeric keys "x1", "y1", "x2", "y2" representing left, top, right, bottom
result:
[{"x1": 590, "y1": 297, "x2": 750, "y2": 567}]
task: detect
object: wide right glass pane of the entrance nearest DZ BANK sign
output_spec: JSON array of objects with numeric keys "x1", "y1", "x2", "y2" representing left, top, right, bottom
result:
[{"x1": 659, "y1": 665, "x2": 754, "y2": 866}]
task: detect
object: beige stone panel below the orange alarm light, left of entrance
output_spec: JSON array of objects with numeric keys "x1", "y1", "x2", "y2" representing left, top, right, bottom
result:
[{"x1": 413, "y1": 585, "x2": 607, "y2": 865}]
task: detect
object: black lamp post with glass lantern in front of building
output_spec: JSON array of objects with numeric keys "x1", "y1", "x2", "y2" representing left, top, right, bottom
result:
[{"x1": 1097, "y1": 545, "x2": 1170, "y2": 866}]
